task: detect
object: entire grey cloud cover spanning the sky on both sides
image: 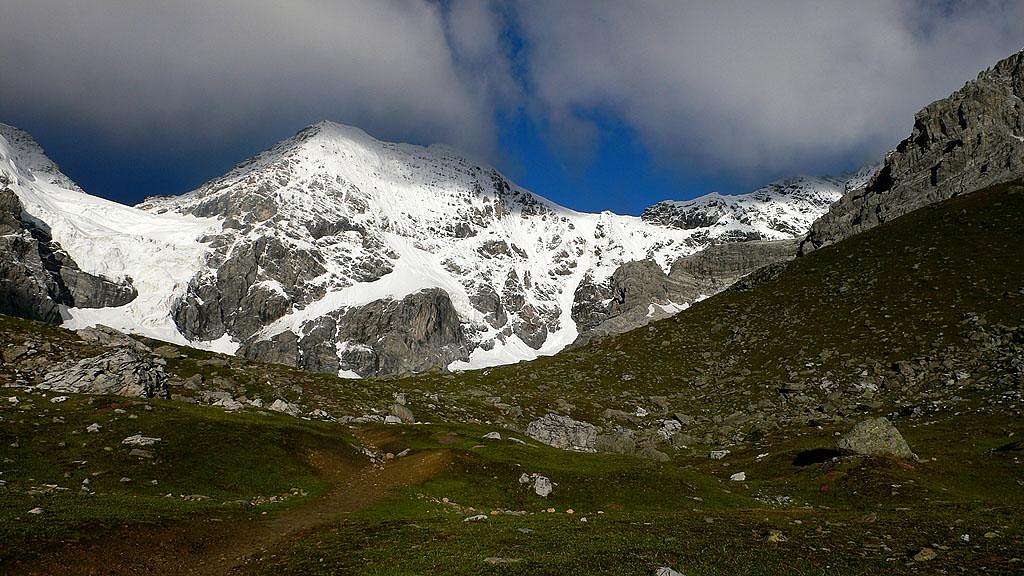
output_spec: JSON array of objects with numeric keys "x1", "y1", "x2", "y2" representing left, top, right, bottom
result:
[{"x1": 0, "y1": 0, "x2": 1024, "y2": 179}]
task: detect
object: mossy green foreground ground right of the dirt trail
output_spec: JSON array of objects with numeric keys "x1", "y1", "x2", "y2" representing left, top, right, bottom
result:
[{"x1": 241, "y1": 409, "x2": 1024, "y2": 575}]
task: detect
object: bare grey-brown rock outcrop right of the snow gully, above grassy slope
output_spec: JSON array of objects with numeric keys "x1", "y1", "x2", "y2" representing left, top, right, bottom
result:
[{"x1": 572, "y1": 240, "x2": 797, "y2": 345}]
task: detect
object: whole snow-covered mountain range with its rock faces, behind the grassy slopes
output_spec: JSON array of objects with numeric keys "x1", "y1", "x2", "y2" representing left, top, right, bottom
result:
[{"x1": 0, "y1": 122, "x2": 849, "y2": 376}]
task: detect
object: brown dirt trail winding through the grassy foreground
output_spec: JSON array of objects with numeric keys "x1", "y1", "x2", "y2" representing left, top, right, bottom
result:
[{"x1": 11, "y1": 436, "x2": 452, "y2": 576}]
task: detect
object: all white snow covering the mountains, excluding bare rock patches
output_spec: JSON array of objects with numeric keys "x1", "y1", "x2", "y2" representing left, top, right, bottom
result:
[{"x1": 0, "y1": 117, "x2": 864, "y2": 377}]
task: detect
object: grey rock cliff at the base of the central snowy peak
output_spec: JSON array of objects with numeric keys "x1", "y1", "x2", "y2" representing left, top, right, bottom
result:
[{"x1": 239, "y1": 288, "x2": 469, "y2": 376}]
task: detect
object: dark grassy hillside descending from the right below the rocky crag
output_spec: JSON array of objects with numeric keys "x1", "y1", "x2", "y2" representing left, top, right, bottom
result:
[{"x1": 402, "y1": 182, "x2": 1024, "y2": 441}]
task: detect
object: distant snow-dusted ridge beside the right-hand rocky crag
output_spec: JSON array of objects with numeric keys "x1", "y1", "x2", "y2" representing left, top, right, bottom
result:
[{"x1": 643, "y1": 165, "x2": 879, "y2": 242}]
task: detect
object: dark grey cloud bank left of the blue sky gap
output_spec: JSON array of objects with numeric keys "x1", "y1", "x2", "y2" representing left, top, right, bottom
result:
[{"x1": 0, "y1": 0, "x2": 509, "y2": 151}]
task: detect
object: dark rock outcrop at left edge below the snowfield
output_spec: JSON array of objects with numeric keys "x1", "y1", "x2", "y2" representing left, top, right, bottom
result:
[{"x1": 0, "y1": 183, "x2": 136, "y2": 324}]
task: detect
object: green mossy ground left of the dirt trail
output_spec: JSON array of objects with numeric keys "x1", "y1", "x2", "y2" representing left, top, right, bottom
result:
[{"x1": 0, "y1": 389, "x2": 359, "y2": 563}]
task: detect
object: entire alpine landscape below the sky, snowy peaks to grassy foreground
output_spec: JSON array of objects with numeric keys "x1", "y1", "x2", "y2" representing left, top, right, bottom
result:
[{"x1": 0, "y1": 33, "x2": 1024, "y2": 576}]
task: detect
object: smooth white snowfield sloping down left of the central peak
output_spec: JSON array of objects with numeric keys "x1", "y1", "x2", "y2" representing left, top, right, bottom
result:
[{"x1": 0, "y1": 124, "x2": 220, "y2": 343}]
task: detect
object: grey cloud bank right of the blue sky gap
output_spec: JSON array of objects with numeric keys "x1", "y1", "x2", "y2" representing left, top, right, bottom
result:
[{"x1": 518, "y1": 0, "x2": 1024, "y2": 171}]
